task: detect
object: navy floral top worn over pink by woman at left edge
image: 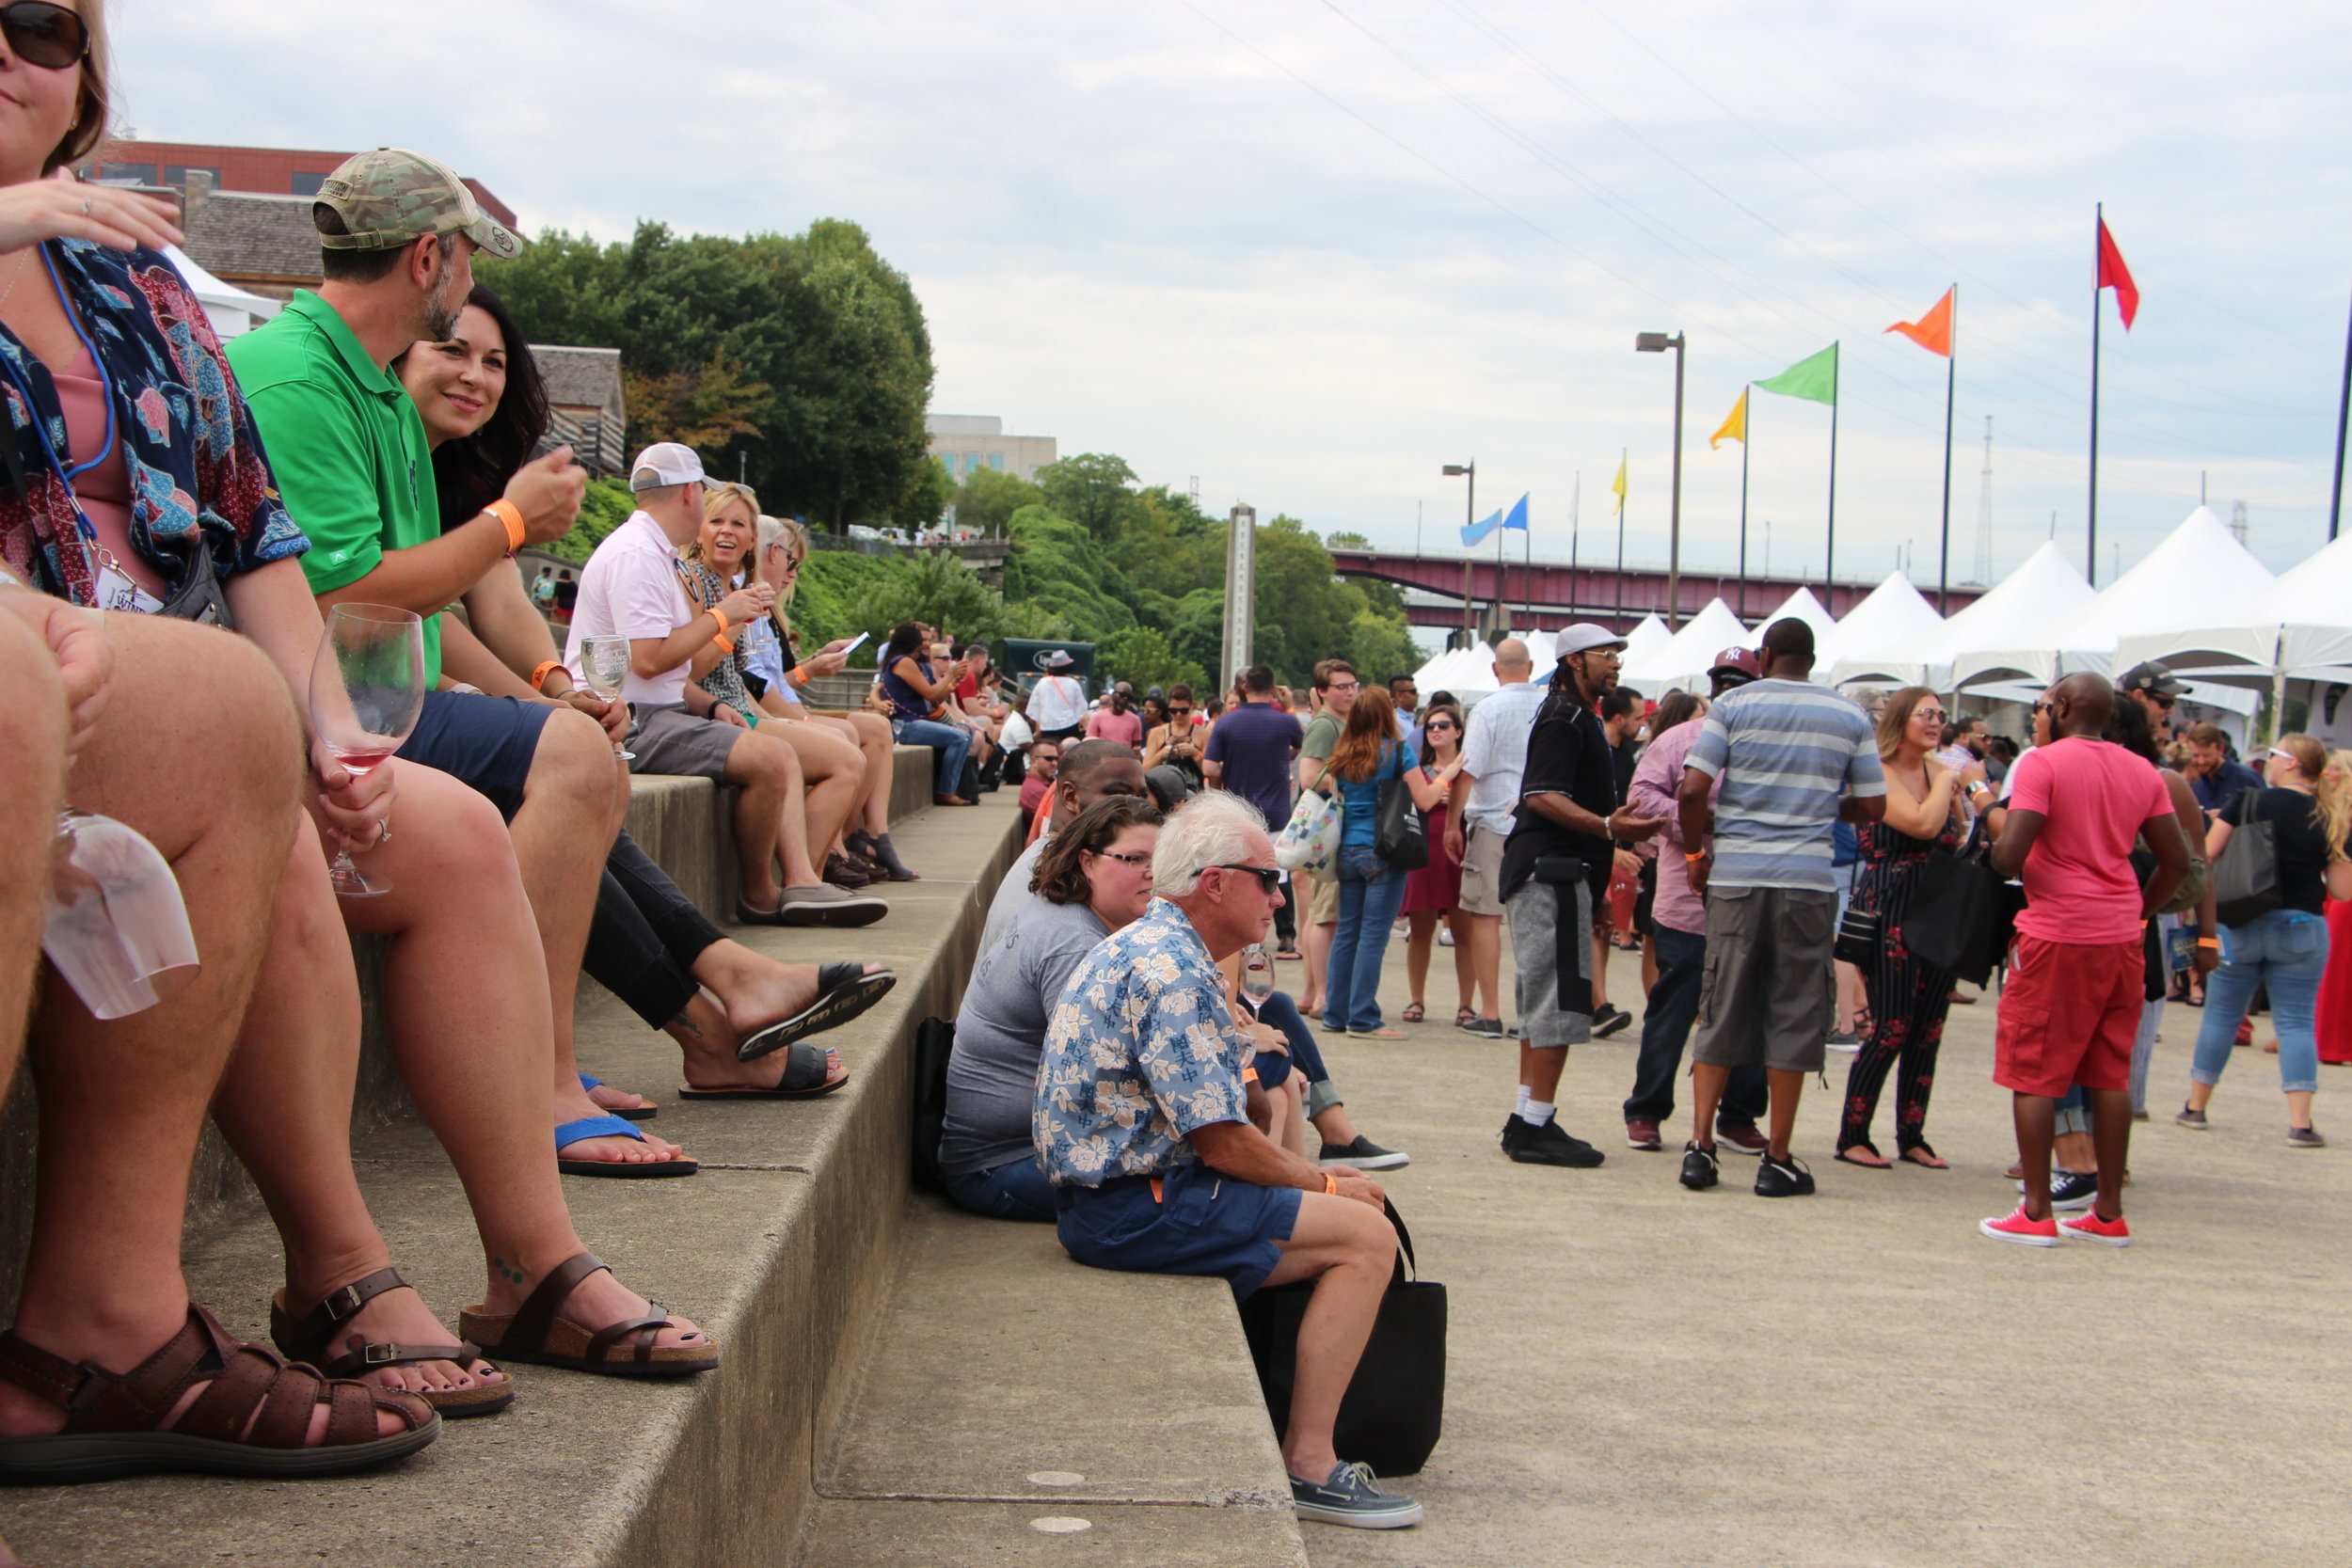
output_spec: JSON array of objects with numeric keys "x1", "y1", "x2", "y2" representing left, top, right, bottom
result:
[{"x1": 0, "y1": 240, "x2": 310, "y2": 604}]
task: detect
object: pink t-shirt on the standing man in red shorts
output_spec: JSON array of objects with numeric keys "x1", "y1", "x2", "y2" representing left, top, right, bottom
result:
[{"x1": 2009, "y1": 736, "x2": 2173, "y2": 947}]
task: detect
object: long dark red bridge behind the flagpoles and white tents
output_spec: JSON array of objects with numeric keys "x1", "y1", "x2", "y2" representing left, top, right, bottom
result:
[{"x1": 1331, "y1": 550, "x2": 1985, "y2": 632}]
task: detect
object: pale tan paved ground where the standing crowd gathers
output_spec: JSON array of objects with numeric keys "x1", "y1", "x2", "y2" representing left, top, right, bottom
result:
[{"x1": 1282, "y1": 941, "x2": 2352, "y2": 1568}]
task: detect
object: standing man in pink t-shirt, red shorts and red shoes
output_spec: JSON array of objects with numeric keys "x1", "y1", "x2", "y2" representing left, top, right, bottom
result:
[{"x1": 1979, "y1": 674, "x2": 2190, "y2": 1246}]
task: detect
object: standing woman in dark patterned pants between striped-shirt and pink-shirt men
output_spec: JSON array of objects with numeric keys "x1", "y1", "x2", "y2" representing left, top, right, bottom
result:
[{"x1": 1837, "y1": 687, "x2": 1990, "y2": 1171}]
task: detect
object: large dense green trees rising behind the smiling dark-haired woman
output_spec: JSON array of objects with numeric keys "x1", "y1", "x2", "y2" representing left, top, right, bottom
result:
[{"x1": 483, "y1": 218, "x2": 939, "y2": 529}]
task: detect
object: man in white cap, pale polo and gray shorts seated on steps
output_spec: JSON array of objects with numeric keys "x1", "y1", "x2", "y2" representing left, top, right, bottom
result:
[{"x1": 564, "y1": 442, "x2": 889, "y2": 927}]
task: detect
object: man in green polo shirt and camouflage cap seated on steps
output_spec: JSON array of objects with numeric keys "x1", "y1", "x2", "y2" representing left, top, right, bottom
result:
[{"x1": 229, "y1": 148, "x2": 691, "y2": 1173}]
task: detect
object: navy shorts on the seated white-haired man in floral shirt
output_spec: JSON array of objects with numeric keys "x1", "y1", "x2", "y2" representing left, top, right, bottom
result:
[{"x1": 1057, "y1": 1164, "x2": 1298, "y2": 1300}]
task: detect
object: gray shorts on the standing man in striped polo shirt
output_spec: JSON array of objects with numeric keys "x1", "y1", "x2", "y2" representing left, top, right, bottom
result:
[{"x1": 1692, "y1": 889, "x2": 1837, "y2": 1072}]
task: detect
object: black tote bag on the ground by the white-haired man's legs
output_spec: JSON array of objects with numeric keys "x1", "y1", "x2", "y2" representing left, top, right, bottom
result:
[{"x1": 1242, "y1": 1204, "x2": 1447, "y2": 1477}]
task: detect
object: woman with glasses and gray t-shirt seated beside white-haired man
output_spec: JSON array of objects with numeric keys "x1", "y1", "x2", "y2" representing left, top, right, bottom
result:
[{"x1": 939, "y1": 795, "x2": 1165, "y2": 1223}]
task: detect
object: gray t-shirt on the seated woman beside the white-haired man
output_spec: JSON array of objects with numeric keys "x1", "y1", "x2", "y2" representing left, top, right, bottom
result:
[{"x1": 939, "y1": 893, "x2": 1110, "y2": 1176}]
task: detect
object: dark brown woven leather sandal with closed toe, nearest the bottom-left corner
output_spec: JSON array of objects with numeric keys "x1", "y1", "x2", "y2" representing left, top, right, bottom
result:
[{"x1": 0, "y1": 1305, "x2": 440, "y2": 1486}]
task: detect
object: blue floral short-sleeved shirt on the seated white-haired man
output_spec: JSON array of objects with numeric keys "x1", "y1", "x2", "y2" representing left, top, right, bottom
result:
[{"x1": 1030, "y1": 898, "x2": 1254, "y2": 1187}]
